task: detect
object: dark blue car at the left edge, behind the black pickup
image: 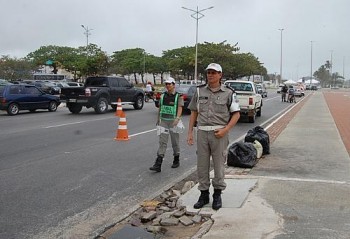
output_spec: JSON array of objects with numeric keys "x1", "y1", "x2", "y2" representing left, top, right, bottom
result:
[{"x1": 0, "y1": 84, "x2": 61, "y2": 115}]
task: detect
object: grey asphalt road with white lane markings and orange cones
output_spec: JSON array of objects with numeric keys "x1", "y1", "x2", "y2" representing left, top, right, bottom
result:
[{"x1": 0, "y1": 91, "x2": 291, "y2": 239}]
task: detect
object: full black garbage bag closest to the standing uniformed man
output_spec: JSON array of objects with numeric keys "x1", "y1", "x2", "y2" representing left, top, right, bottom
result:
[{"x1": 227, "y1": 142, "x2": 258, "y2": 168}]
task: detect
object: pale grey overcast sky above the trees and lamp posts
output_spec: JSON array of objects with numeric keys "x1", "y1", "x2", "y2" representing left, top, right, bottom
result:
[{"x1": 0, "y1": 0, "x2": 350, "y2": 80}]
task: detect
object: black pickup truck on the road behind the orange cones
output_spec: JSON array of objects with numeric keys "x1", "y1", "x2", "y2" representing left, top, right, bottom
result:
[{"x1": 61, "y1": 76, "x2": 145, "y2": 114}]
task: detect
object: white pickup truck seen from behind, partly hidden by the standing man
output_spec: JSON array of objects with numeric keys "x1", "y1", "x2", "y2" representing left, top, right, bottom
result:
[{"x1": 225, "y1": 80, "x2": 263, "y2": 123}]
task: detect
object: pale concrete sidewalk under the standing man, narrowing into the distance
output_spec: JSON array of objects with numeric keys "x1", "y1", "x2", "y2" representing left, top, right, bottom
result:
[{"x1": 180, "y1": 92, "x2": 350, "y2": 239}]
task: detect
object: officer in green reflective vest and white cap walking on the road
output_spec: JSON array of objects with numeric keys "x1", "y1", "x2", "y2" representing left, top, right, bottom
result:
[{"x1": 149, "y1": 77, "x2": 184, "y2": 172}]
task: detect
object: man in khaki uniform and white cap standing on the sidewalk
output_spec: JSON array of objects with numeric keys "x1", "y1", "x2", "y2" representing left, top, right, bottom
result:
[{"x1": 187, "y1": 63, "x2": 240, "y2": 210}]
